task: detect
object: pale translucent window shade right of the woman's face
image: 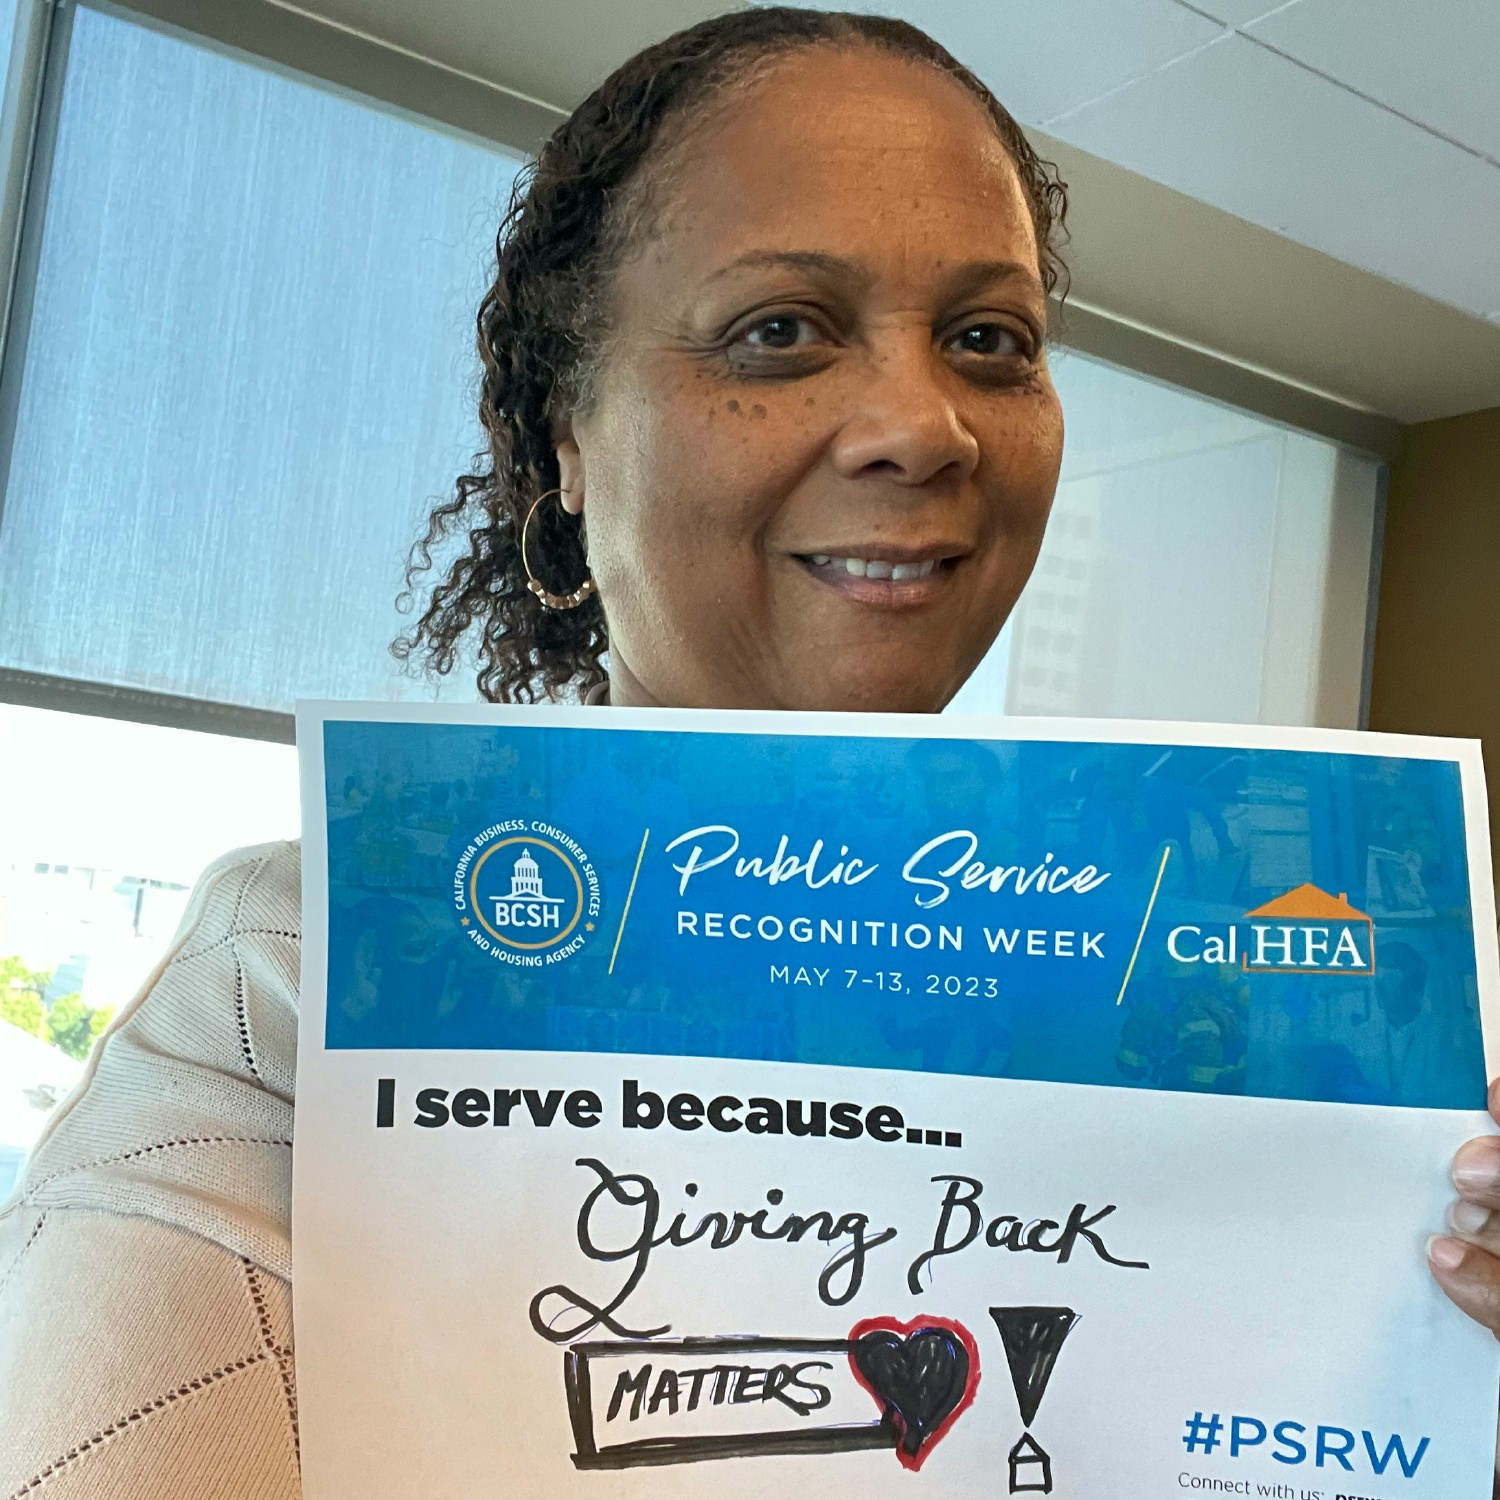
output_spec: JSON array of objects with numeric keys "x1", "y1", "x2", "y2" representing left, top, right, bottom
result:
[{"x1": 953, "y1": 353, "x2": 1379, "y2": 728}]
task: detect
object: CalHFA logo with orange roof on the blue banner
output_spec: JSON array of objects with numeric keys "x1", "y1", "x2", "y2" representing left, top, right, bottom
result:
[{"x1": 1167, "y1": 885, "x2": 1376, "y2": 975}]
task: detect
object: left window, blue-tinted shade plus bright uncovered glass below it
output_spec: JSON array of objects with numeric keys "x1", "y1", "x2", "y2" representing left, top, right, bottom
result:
[{"x1": 0, "y1": 0, "x2": 519, "y2": 1197}]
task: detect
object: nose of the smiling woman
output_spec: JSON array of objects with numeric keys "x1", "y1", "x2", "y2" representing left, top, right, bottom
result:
[{"x1": 833, "y1": 341, "x2": 980, "y2": 485}]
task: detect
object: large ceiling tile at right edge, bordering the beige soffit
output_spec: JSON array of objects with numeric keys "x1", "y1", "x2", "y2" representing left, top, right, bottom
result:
[{"x1": 1055, "y1": 35, "x2": 1500, "y2": 314}]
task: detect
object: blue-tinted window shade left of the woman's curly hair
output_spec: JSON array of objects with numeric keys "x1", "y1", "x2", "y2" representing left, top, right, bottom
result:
[{"x1": 0, "y1": 9, "x2": 519, "y2": 710}]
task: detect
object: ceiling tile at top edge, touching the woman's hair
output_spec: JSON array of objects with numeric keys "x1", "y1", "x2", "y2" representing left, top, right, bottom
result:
[{"x1": 804, "y1": 0, "x2": 1224, "y2": 125}]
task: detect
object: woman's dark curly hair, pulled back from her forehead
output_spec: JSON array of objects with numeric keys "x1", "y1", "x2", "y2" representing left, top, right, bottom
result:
[{"x1": 392, "y1": 6, "x2": 1068, "y2": 702}]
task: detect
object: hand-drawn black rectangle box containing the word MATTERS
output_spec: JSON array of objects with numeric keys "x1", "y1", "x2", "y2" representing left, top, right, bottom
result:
[{"x1": 563, "y1": 1338, "x2": 897, "y2": 1469}]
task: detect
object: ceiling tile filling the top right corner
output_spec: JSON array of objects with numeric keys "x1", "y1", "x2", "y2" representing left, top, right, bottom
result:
[{"x1": 1248, "y1": 0, "x2": 1500, "y2": 162}]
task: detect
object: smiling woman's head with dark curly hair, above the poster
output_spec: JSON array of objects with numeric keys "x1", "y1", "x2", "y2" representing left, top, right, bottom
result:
[{"x1": 398, "y1": 9, "x2": 1065, "y2": 711}]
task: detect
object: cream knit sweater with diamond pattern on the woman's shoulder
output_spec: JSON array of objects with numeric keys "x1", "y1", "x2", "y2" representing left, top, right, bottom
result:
[{"x1": 0, "y1": 843, "x2": 302, "y2": 1500}]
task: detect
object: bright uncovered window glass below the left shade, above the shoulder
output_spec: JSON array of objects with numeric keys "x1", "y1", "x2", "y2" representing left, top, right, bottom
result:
[{"x1": 0, "y1": 704, "x2": 299, "y2": 1199}]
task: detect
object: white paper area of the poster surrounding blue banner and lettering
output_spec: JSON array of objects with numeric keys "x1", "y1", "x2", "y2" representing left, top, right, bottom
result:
[{"x1": 294, "y1": 710, "x2": 1500, "y2": 1500}]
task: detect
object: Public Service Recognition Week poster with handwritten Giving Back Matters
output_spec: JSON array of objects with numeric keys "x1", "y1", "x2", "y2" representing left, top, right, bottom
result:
[{"x1": 294, "y1": 705, "x2": 1500, "y2": 1500}]
